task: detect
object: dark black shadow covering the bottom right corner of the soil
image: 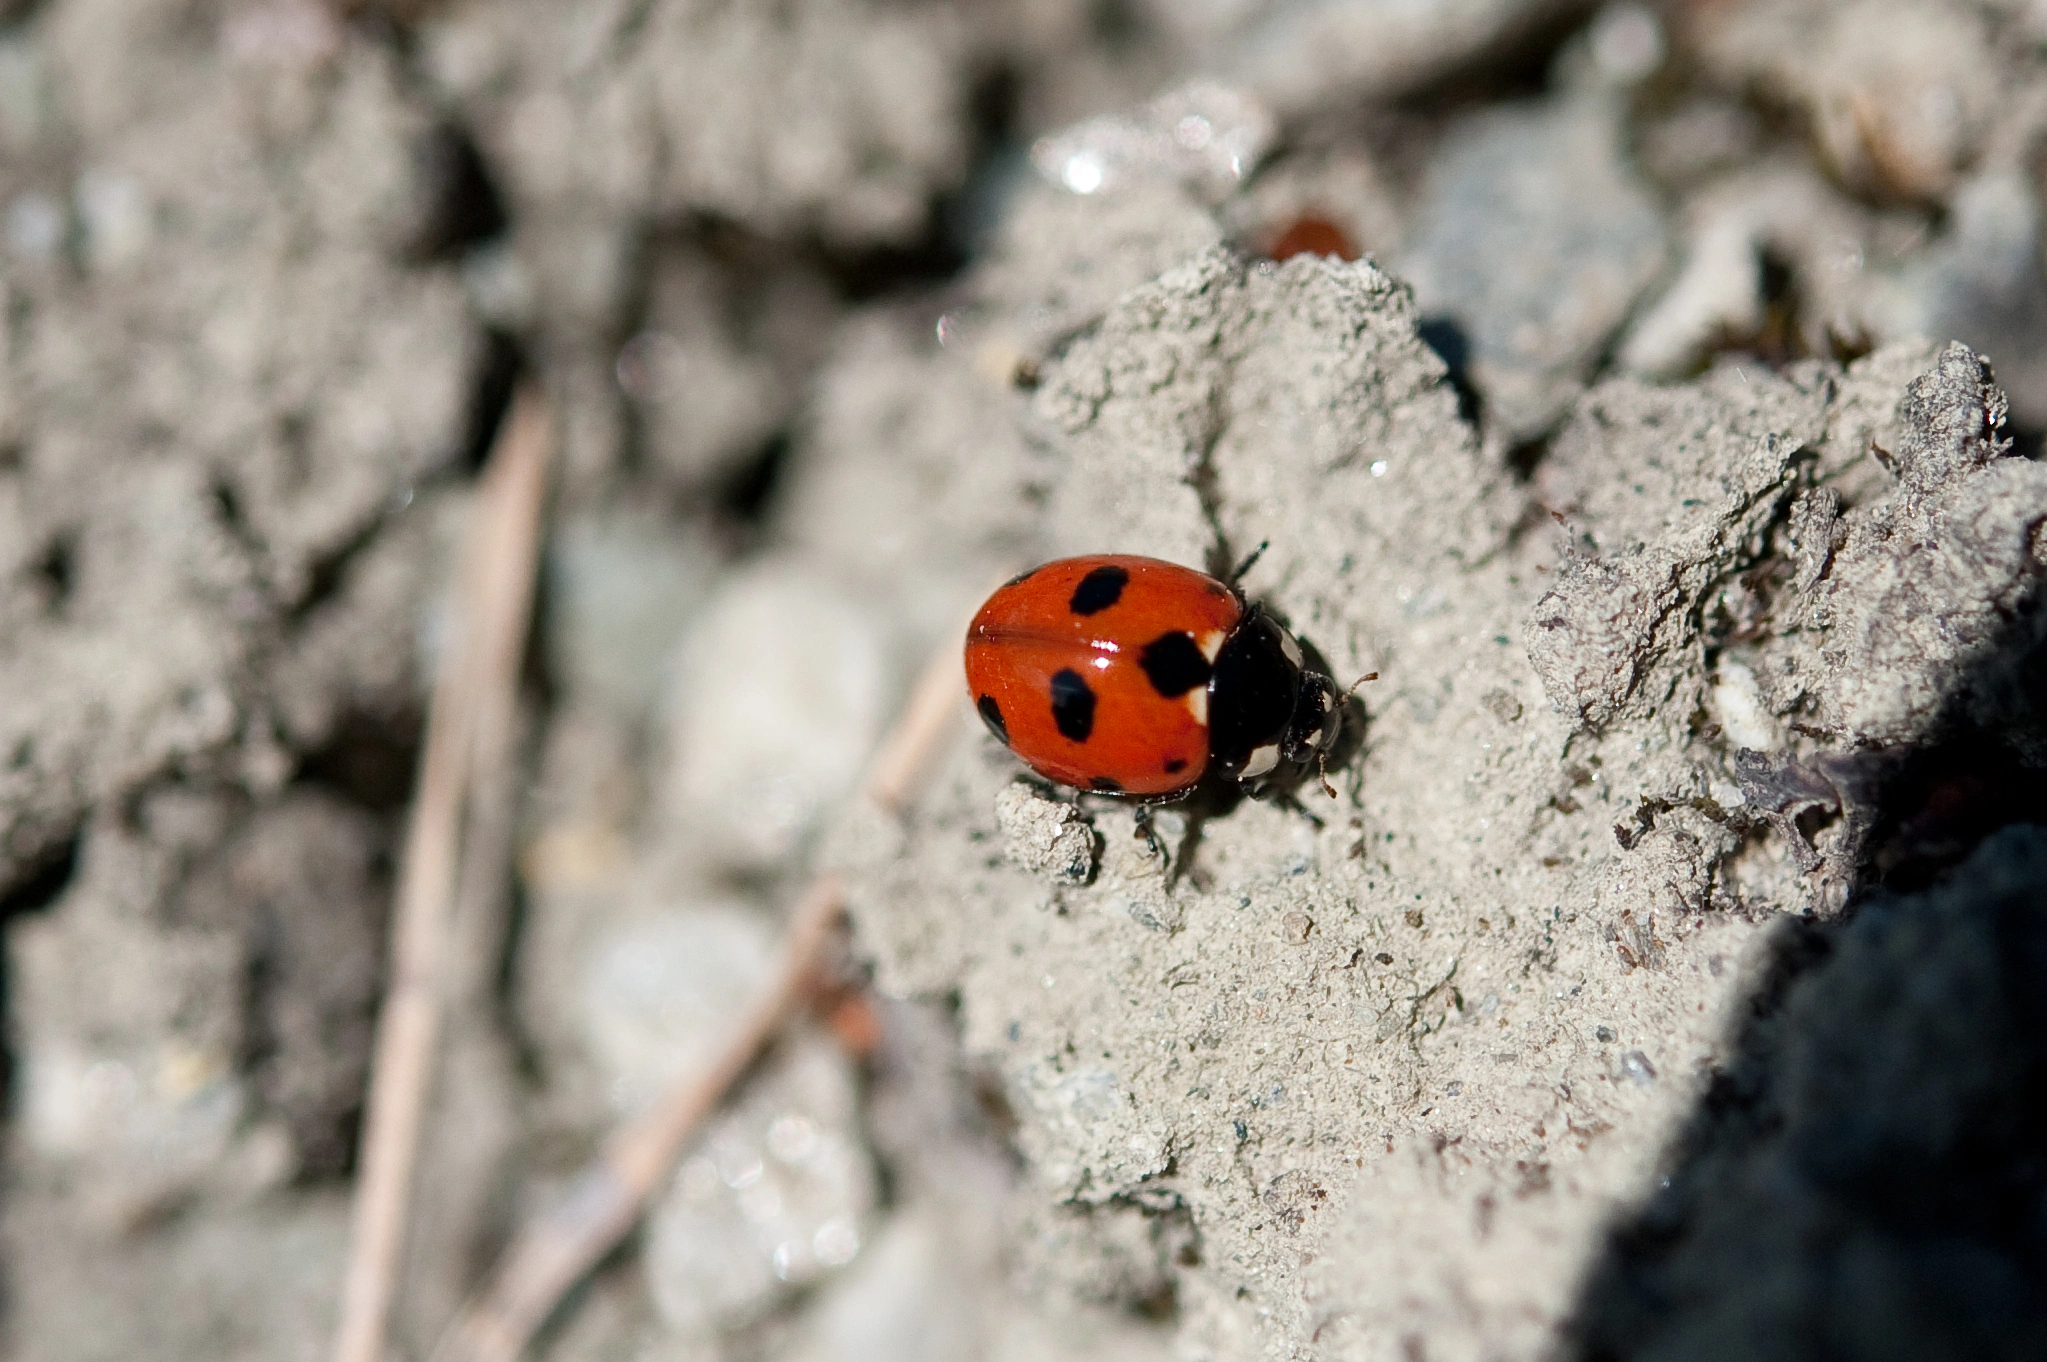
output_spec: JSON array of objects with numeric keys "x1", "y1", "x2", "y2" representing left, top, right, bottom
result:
[{"x1": 1560, "y1": 569, "x2": 2047, "y2": 1362}]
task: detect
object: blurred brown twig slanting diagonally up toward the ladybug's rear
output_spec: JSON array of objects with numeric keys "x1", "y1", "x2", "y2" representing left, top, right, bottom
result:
[{"x1": 434, "y1": 643, "x2": 962, "y2": 1362}]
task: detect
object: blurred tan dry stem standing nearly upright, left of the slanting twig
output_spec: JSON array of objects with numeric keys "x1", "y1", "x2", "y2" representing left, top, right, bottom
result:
[{"x1": 334, "y1": 391, "x2": 553, "y2": 1362}]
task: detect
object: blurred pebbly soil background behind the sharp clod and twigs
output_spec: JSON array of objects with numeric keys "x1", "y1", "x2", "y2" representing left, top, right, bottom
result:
[{"x1": 0, "y1": 0, "x2": 2047, "y2": 1362}]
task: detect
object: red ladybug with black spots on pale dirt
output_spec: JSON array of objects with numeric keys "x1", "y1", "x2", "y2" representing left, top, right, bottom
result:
[{"x1": 966, "y1": 553, "x2": 1343, "y2": 803}]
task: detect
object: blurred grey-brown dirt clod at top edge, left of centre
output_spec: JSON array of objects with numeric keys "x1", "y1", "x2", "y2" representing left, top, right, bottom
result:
[{"x1": 424, "y1": 0, "x2": 976, "y2": 259}]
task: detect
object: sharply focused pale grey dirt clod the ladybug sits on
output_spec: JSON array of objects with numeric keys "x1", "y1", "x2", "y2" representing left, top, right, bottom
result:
[{"x1": 835, "y1": 231, "x2": 2031, "y2": 1358}]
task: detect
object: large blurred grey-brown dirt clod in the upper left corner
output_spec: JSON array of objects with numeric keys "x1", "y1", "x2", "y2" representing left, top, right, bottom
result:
[{"x1": 0, "y1": 0, "x2": 479, "y2": 881}]
